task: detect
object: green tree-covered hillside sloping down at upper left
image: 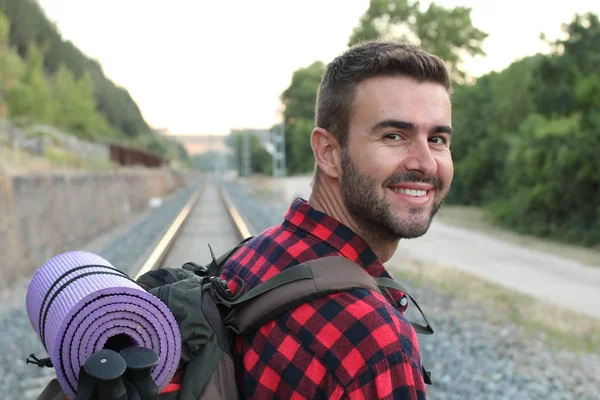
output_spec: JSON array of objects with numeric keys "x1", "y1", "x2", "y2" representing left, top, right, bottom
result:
[{"x1": 0, "y1": 0, "x2": 189, "y2": 164}]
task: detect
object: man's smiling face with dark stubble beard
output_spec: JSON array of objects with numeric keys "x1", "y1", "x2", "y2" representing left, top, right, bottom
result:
[{"x1": 340, "y1": 77, "x2": 454, "y2": 239}]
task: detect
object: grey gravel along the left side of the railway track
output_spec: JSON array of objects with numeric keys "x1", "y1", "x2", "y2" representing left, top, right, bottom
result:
[{"x1": 0, "y1": 183, "x2": 195, "y2": 400}]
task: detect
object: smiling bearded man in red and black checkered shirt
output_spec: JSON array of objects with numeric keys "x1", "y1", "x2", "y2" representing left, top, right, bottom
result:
[{"x1": 222, "y1": 41, "x2": 454, "y2": 400}]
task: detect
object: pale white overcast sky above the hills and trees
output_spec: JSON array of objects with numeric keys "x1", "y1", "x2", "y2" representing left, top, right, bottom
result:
[{"x1": 39, "y1": 0, "x2": 600, "y2": 134}]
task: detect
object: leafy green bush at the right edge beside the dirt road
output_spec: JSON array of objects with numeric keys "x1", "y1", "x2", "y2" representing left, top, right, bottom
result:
[{"x1": 490, "y1": 113, "x2": 600, "y2": 245}]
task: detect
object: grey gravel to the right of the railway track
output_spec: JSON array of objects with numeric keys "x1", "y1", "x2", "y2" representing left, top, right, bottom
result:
[{"x1": 225, "y1": 177, "x2": 600, "y2": 400}]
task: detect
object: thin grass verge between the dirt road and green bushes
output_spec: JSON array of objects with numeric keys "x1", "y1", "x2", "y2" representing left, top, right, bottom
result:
[{"x1": 435, "y1": 205, "x2": 600, "y2": 268}]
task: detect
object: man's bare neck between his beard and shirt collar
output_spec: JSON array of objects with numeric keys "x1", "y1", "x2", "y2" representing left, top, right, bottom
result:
[{"x1": 308, "y1": 178, "x2": 399, "y2": 263}]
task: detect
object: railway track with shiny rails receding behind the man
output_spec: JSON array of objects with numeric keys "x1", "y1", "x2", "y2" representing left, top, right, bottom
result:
[{"x1": 21, "y1": 181, "x2": 251, "y2": 400}]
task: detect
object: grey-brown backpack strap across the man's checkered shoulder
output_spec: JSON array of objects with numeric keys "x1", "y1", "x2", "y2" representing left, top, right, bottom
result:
[{"x1": 224, "y1": 256, "x2": 433, "y2": 335}]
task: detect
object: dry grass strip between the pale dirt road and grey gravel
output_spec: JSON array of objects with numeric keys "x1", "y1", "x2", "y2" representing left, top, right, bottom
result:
[{"x1": 390, "y1": 261, "x2": 600, "y2": 354}]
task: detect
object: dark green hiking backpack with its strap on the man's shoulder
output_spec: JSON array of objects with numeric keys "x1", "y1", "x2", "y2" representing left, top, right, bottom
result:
[{"x1": 39, "y1": 238, "x2": 433, "y2": 400}]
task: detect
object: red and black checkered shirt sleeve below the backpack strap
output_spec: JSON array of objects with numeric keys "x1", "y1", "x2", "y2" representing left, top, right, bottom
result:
[{"x1": 238, "y1": 289, "x2": 425, "y2": 400}]
